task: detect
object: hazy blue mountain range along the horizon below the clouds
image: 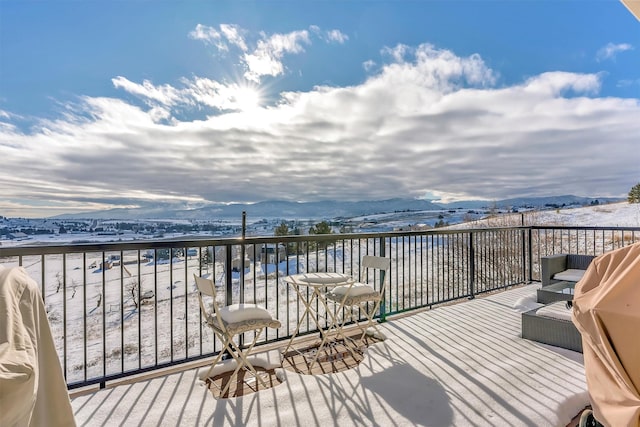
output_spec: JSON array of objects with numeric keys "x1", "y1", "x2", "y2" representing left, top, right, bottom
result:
[{"x1": 55, "y1": 195, "x2": 621, "y2": 220}]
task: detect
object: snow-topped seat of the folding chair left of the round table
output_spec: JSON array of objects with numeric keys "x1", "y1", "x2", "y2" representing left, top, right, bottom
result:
[{"x1": 207, "y1": 304, "x2": 281, "y2": 335}]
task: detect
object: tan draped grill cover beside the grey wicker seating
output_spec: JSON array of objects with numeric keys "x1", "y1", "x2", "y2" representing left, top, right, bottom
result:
[{"x1": 572, "y1": 244, "x2": 640, "y2": 427}]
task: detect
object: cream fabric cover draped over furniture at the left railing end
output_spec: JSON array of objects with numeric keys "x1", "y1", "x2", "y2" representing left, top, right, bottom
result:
[{"x1": 0, "y1": 266, "x2": 76, "y2": 427}]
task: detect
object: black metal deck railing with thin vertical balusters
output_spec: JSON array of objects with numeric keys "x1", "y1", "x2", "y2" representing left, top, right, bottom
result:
[{"x1": 0, "y1": 227, "x2": 640, "y2": 388}]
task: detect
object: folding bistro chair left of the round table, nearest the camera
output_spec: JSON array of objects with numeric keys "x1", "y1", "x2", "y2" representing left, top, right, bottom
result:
[{"x1": 193, "y1": 274, "x2": 280, "y2": 397}]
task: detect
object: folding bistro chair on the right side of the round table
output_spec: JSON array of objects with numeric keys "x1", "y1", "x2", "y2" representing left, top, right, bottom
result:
[{"x1": 326, "y1": 255, "x2": 391, "y2": 340}]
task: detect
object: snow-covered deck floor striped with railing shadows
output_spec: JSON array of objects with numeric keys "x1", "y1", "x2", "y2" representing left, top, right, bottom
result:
[{"x1": 72, "y1": 285, "x2": 589, "y2": 426}]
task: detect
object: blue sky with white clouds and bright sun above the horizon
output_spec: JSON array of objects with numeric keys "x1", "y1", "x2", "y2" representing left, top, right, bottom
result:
[{"x1": 0, "y1": 0, "x2": 640, "y2": 216}]
